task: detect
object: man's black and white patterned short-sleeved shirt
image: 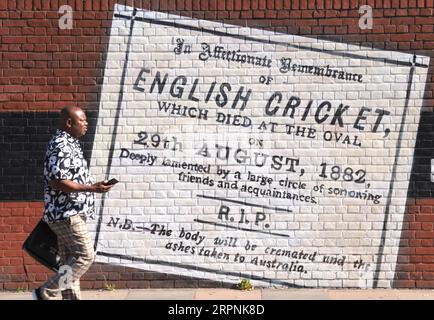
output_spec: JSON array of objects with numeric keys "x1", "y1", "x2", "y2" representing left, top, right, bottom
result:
[{"x1": 44, "y1": 129, "x2": 95, "y2": 223}]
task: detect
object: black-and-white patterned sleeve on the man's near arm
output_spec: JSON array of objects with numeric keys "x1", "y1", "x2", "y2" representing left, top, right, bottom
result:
[{"x1": 47, "y1": 147, "x2": 73, "y2": 181}]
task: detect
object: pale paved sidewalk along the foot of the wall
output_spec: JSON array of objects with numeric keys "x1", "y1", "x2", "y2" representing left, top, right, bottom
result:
[{"x1": 0, "y1": 288, "x2": 434, "y2": 300}]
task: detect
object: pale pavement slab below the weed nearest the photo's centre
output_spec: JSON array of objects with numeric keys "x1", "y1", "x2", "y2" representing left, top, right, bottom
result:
[{"x1": 195, "y1": 289, "x2": 262, "y2": 300}]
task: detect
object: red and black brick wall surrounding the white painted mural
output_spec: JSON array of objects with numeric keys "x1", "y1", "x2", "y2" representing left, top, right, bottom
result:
[{"x1": 0, "y1": 0, "x2": 434, "y2": 290}]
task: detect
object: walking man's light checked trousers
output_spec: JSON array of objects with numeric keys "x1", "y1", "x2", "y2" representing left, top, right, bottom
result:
[{"x1": 41, "y1": 215, "x2": 95, "y2": 300}]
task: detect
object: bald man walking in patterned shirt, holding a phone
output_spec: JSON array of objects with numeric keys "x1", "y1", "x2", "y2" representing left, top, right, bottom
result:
[{"x1": 32, "y1": 107, "x2": 112, "y2": 300}]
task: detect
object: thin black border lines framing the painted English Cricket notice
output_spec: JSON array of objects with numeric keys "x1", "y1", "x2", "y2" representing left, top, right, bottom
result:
[{"x1": 94, "y1": 8, "x2": 428, "y2": 288}]
